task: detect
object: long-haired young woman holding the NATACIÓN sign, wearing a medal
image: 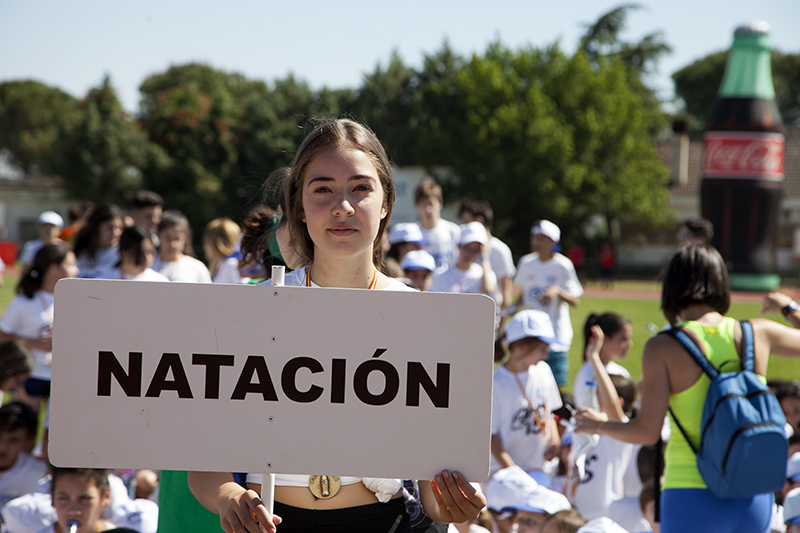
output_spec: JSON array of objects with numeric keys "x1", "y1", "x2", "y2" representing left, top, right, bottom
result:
[{"x1": 189, "y1": 120, "x2": 486, "y2": 533}]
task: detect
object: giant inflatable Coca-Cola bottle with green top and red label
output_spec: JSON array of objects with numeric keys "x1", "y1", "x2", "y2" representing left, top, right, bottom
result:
[{"x1": 701, "y1": 22, "x2": 784, "y2": 291}]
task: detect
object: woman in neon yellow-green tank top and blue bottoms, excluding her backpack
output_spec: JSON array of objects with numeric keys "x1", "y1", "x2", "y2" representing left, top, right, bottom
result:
[{"x1": 576, "y1": 244, "x2": 800, "y2": 533}]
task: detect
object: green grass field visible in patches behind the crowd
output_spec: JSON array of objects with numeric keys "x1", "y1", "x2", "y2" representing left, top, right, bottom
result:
[{"x1": 0, "y1": 276, "x2": 800, "y2": 383}]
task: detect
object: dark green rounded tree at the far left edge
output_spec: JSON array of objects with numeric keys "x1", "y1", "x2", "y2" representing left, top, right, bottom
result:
[{"x1": 0, "y1": 80, "x2": 79, "y2": 175}]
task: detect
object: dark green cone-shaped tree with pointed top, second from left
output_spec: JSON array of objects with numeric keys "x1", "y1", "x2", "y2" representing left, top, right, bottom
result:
[{"x1": 55, "y1": 77, "x2": 159, "y2": 203}]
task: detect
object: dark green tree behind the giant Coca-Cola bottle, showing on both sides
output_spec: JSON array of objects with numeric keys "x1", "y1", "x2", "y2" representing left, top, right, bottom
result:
[{"x1": 672, "y1": 50, "x2": 800, "y2": 129}]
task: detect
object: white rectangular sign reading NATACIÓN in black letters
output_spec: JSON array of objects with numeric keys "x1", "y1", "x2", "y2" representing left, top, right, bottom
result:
[{"x1": 49, "y1": 279, "x2": 495, "y2": 481}]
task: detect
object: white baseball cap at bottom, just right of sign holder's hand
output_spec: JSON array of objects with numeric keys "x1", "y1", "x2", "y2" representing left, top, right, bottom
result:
[{"x1": 486, "y1": 465, "x2": 570, "y2": 514}]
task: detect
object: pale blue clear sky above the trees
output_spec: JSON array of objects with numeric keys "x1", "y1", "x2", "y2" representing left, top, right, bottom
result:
[{"x1": 0, "y1": 0, "x2": 800, "y2": 111}]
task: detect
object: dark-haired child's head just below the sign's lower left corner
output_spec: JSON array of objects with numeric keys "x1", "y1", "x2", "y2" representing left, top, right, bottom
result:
[{"x1": 53, "y1": 474, "x2": 110, "y2": 533}]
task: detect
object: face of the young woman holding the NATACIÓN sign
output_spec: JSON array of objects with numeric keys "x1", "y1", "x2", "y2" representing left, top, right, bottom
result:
[{"x1": 302, "y1": 147, "x2": 388, "y2": 262}]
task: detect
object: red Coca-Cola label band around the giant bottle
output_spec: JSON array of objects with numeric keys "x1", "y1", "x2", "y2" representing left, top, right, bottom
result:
[{"x1": 703, "y1": 132, "x2": 784, "y2": 179}]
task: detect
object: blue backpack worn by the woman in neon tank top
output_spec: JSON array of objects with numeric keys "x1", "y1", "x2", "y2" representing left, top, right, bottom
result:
[{"x1": 668, "y1": 320, "x2": 788, "y2": 498}]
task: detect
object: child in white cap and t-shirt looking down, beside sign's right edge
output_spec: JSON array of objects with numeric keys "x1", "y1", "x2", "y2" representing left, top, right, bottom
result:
[{"x1": 491, "y1": 310, "x2": 561, "y2": 486}]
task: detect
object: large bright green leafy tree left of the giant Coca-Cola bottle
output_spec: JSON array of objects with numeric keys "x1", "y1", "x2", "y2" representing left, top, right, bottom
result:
[{"x1": 412, "y1": 43, "x2": 669, "y2": 254}]
